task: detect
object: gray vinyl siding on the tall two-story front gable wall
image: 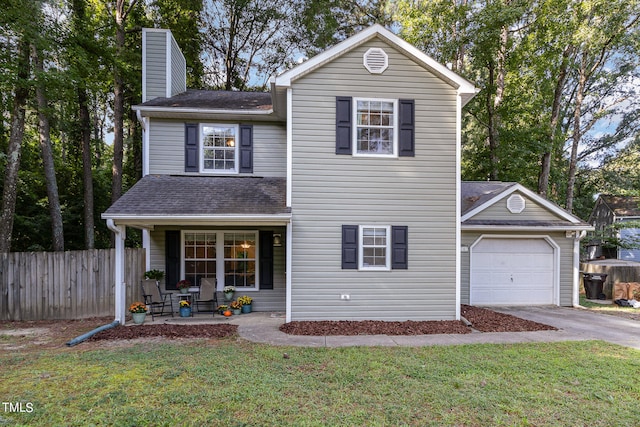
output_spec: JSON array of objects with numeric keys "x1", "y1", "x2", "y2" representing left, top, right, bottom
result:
[{"x1": 291, "y1": 40, "x2": 457, "y2": 320}]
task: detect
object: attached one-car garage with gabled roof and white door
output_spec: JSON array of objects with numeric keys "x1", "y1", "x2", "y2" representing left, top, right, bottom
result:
[{"x1": 460, "y1": 181, "x2": 593, "y2": 306}]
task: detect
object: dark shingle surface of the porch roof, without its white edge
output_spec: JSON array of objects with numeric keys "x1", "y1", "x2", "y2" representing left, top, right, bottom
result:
[{"x1": 103, "y1": 175, "x2": 290, "y2": 217}]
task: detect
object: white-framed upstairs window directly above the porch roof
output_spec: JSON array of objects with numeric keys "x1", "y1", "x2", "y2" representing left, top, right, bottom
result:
[{"x1": 201, "y1": 124, "x2": 238, "y2": 173}]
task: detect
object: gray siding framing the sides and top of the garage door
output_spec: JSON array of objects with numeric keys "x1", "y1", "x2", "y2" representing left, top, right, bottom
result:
[{"x1": 460, "y1": 230, "x2": 573, "y2": 307}]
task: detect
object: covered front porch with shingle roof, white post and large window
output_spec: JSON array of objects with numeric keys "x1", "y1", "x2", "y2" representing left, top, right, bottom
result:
[{"x1": 102, "y1": 176, "x2": 291, "y2": 323}]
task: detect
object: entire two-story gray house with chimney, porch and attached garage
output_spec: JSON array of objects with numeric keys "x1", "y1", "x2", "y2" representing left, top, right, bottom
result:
[{"x1": 103, "y1": 25, "x2": 590, "y2": 321}]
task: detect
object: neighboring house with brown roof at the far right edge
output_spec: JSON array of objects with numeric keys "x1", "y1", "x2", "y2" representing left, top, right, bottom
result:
[{"x1": 589, "y1": 194, "x2": 640, "y2": 262}]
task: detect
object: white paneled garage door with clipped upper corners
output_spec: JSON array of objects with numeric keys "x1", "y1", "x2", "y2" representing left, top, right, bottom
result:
[{"x1": 470, "y1": 238, "x2": 556, "y2": 305}]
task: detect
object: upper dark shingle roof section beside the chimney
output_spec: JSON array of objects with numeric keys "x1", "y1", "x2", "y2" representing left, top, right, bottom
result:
[{"x1": 141, "y1": 89, "x2": 273, "y2": 110}]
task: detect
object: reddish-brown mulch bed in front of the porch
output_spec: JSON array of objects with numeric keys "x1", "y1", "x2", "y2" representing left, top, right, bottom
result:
[{"x1": 89, "y1": 325, "x2": 238, "y2": 341}]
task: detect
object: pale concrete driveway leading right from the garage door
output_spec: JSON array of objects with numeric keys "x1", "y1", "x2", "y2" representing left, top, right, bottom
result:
[{"x1": 487, "y1": 306, "x2": 640, "y2": 349}]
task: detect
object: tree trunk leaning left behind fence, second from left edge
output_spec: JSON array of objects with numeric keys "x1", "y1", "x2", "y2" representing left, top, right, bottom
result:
[{"x1": 31, "y1": 45, "x2": 64, "y2": 251}]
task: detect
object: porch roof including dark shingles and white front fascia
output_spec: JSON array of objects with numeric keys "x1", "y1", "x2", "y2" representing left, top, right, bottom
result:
[{"x1": 102, "y1": 175, "x2": 291, "y2": 228}]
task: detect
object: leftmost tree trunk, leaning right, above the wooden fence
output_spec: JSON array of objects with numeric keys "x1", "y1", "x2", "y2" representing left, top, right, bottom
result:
[{"x1": 0, "y1": 41, "x2": 29, "y2": 253}]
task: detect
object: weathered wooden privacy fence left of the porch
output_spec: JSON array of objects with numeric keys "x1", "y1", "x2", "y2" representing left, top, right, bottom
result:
[{"x1": 0, "y1": 249, "x2": 145, "y2": 320}]
